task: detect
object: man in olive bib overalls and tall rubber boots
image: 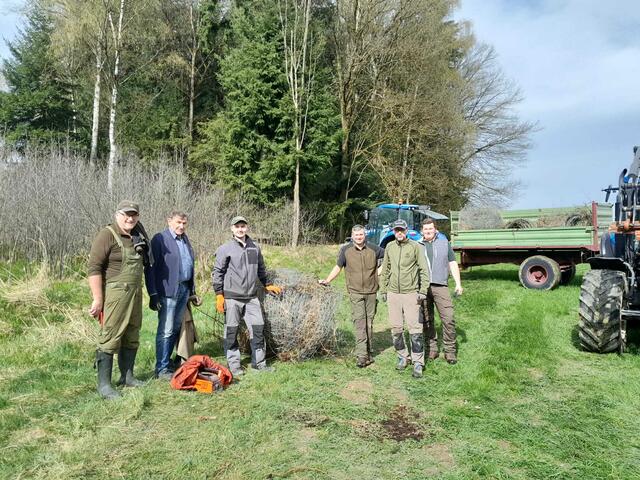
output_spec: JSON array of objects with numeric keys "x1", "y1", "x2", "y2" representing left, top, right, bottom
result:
[{"x1": 88, "y1": 200, "x2": 149, "y2": 399}]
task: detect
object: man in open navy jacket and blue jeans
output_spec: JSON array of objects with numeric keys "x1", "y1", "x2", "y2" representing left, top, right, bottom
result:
[{"x1": 147, "y1": 211, "x2": 195, "y2": 380}]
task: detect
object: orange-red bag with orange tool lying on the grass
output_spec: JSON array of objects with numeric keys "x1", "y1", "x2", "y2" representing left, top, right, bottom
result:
[{"x1": 171, "y1": 355, "x2": 233, "y2": 393}]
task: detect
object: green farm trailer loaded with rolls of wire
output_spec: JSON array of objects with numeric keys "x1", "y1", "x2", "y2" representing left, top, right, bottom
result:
[{"x1": 450, "y1": 202, "x2": 613, "y2": 290}]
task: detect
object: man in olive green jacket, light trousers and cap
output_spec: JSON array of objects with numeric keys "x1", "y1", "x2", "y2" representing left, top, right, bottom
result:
[{"x1": 380, "y1": 220, "x2": 429, "y2": 378}]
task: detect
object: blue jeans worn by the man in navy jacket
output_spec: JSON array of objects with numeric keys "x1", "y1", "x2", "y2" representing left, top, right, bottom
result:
[{"x1": 156, "y1": 283, "x2": 189, "y2": 374}]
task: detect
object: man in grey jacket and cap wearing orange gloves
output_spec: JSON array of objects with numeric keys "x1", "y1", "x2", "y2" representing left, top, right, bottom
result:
[{"x1": 212, "y1": 216, "x2": 282, "y2": 377}]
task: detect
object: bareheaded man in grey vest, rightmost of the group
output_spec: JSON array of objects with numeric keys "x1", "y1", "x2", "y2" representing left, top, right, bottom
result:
[{"x1": 420, "y1": 217, "x2": 462, "y2": 365}]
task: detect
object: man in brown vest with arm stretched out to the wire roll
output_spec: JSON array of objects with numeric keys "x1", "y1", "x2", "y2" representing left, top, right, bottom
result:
[{"x1": 318, "y1": 225, "x2": 384, "y2": 368}]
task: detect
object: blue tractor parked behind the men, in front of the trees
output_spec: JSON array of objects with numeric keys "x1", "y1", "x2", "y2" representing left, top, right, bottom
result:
[{"x1": 364, "y1": 203, "x2": 448, "y2": 248}]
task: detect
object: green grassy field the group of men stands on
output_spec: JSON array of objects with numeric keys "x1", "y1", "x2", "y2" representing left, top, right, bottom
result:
[{"x1": 0, "y1": 247, "x2": 640, "y2": 480}]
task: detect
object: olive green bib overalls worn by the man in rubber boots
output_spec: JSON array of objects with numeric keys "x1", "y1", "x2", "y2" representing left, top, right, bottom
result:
[{"x1": 98, "y1": 234, "x2": 143, "y2": 354}]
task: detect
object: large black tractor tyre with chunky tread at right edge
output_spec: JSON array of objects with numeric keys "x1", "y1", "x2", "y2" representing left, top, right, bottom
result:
[{"x1": 578, "y1": 270, "x2": 627, "y2": 353}]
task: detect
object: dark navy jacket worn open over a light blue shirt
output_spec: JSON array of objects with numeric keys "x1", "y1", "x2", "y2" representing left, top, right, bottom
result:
[{"x1": 147, "y1": 228, "x2": 196, "y2": 297}]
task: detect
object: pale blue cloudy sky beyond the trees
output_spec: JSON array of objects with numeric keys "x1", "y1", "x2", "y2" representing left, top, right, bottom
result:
[{"x1": 0, "y1": 0, "x2": 640, "y2": 208}]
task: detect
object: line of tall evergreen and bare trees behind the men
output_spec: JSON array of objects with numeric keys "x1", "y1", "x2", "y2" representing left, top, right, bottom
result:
[{"x1": 0, "y1": 0, "x2": 534, "y2": 240}]
